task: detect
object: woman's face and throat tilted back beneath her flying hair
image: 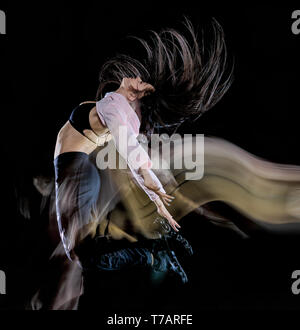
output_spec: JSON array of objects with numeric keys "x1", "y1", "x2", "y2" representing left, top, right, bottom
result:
[{"x1": 116, "y1": 77, "x2": 155, "y2": 102}]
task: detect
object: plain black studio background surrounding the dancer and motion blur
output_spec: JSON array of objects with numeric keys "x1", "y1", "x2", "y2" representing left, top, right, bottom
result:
[{"x1": 0, "y1": 1, "x2": 300, "y2": 312}]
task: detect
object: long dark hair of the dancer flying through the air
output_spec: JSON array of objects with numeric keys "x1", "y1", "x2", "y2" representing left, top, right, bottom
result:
[{"x1": 96, "y1": 17, "x2": 233, "y2": 135}]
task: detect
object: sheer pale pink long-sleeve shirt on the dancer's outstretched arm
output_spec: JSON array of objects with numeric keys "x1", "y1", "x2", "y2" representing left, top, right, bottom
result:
[{"x1": 96, "y1": 92, "x2": 165, "y2": 201}]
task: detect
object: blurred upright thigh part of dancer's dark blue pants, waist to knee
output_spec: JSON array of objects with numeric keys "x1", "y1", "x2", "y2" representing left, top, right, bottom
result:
[{"x1": 54, "y1": 152, "x2": 100, "y2": 259}]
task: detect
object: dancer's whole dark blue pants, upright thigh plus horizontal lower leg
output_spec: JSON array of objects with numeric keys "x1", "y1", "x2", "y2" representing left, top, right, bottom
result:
[{"x1": 54, "y1": 152, "x2": 152, "y2": 270}]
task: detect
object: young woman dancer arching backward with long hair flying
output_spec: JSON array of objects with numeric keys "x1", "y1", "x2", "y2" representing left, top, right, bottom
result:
[{"x1": 30, "y1": 20, "x2": 232, "y2": 308}]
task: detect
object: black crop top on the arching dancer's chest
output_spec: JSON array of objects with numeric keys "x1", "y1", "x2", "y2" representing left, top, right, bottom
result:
[{"x1": 69, "y1": 103, "x2": 95, "y2": 135}]
